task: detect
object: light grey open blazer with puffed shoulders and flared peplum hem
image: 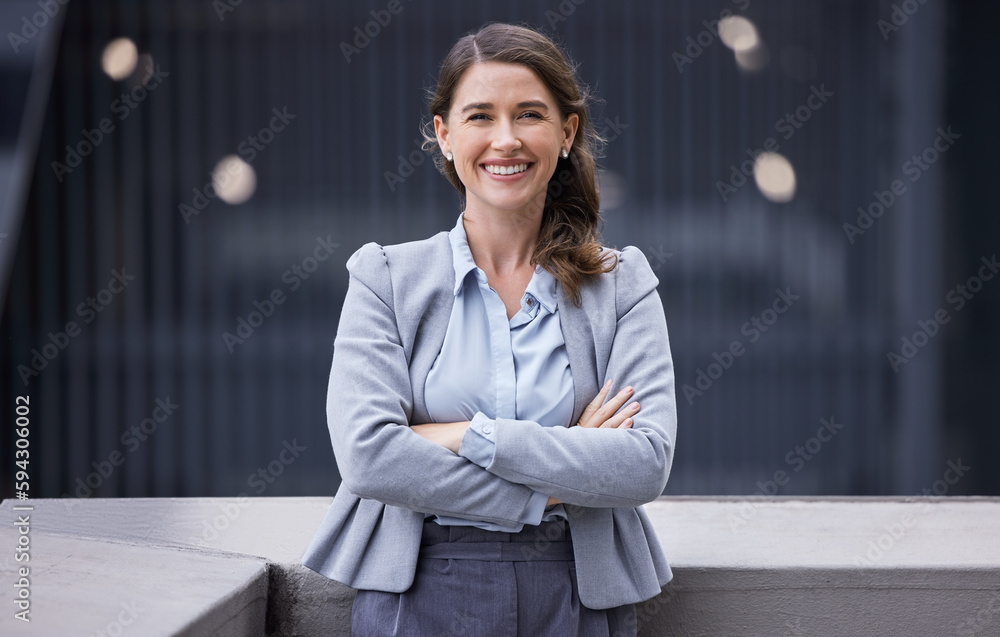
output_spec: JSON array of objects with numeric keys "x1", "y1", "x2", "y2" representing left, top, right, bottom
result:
[{"x1": 302, "y1": 232, "x2": 677, "y2": 609}]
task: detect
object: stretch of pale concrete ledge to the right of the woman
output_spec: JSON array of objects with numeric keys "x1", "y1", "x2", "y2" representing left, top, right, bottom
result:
[{"x1": 639, "y1": 497, "x2": 1000, "y2": 637}]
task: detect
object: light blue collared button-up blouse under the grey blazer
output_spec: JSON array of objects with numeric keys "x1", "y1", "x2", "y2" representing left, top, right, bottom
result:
[{"x1": 424, "y1": 213, "x2": 574, "y2": 532}]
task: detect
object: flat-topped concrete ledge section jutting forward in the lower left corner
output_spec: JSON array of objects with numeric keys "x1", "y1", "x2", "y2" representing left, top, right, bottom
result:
[{"x1": 0, "y1": 520, "x2": 268, "y2": 637}]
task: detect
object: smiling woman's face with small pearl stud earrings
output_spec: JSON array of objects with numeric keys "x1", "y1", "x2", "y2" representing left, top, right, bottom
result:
[{"x1": 434, "y1": 62, "x2": 579, "y2": 219}]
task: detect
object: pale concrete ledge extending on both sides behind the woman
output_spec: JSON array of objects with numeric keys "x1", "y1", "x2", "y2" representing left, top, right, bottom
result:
[{"x1": 0, "y1": 497, "x2": 1000, "y2": 637}]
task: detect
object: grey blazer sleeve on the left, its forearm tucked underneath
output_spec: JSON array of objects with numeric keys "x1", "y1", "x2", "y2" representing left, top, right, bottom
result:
[{"x1": 327, "y1": 243, "x2": 534, "y2": 526}]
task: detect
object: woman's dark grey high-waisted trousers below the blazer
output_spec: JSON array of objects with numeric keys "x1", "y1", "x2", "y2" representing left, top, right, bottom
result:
[{"x1": 351, "y1": 519, "x2": 636, "y2": 637}]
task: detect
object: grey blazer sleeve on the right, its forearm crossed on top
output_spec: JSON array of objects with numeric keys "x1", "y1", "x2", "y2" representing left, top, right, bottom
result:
[{"x1": 472, "y1": 246, "x2": 677, "y2": 507}]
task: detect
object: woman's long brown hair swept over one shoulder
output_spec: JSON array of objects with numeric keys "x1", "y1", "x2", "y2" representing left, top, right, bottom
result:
[{"x1": 423, "y1": 23, "x2": 618, "y2": 307}]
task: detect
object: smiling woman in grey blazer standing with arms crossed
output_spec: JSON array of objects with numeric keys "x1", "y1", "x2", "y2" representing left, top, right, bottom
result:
[{"x1": 303, "y1": 24, "x2": 676, "y2": 636}]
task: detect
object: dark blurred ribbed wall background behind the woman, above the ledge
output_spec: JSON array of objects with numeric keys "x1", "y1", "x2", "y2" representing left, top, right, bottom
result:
[{"x1": 0, "y1": 0, "x2": 1000, "y2": 497}]
